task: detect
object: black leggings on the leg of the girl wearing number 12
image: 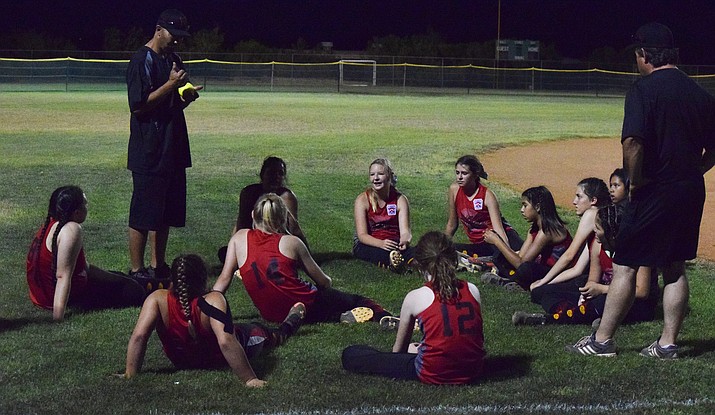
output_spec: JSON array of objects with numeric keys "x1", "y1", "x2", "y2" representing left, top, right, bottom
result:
[{"x1": 342, "y1": 345, "x2": 419, "y2": 380}]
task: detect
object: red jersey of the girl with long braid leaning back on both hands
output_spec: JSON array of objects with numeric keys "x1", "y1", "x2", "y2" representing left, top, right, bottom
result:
[{"x1": 156, "y1": 290, "x2": 228, "y2": 369}]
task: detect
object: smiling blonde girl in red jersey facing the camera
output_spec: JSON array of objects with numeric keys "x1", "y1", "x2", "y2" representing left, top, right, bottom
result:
[{"x1": 353, "y1": 158, "x2": 412, "y2": 272}]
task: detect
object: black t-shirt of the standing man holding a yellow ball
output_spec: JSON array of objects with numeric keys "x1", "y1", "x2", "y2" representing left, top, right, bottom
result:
[{"x1": 127, "y1": 46, "x2": 191, "y2": 175}]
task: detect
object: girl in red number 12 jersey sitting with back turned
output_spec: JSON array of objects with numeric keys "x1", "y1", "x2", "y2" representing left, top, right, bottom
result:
[{"x1": 342, "y1": 231, "x2": 485, "y2": 384}]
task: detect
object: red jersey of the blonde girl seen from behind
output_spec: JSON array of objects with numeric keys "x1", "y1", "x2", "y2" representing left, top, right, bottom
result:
[{"x1": 240, "y1": 229, "x2": 318, "y2": 323}]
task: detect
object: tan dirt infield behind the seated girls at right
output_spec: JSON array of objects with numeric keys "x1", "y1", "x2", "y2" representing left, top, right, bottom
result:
[{"x1": 479, "y1": 138, "x2": 715, "y2": 261}]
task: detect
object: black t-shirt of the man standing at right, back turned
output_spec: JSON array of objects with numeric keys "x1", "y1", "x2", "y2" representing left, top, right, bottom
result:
[{"x1": 621, "y1": 68, "x2": 715, "y2": 183}]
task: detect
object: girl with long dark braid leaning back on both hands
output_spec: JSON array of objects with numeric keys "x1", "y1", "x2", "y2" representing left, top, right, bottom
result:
[{"x1": 124, "y1": 255, "x2": 305, "y2": 388}]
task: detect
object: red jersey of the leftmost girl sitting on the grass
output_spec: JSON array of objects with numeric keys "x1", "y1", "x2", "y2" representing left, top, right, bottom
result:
[{"x1": 26, "y1": 219, "x2": 87, "y2": 310}]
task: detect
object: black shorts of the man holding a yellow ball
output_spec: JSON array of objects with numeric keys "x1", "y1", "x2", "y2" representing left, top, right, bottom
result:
[{"x1": 129, "y1": 169, "x2": 186, "y2": 231}]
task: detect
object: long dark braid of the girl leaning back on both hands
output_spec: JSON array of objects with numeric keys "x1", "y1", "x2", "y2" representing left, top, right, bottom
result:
[{"x1": 171, "y1": 254, "x2": 208, "y2": 339}]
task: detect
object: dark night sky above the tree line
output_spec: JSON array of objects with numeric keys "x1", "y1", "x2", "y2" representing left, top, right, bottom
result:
[{"x1": 0, "y1": 0, "x2": 715, "y2": 65}]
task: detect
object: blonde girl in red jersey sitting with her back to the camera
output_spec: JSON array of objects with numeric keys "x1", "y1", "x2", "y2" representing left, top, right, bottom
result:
[{"x1": 213, "y1": 193, "x2": 390, "y2": 323}]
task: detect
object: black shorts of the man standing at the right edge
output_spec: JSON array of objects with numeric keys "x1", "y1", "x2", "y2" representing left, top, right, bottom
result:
[{"x1": 613, "y1": 180, "x2": 705, "y2": 267}]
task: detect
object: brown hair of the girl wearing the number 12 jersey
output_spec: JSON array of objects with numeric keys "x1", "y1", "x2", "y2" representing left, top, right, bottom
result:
[{"x1": 415, "y1": 231, "x2": 461, "y2": 303}]
